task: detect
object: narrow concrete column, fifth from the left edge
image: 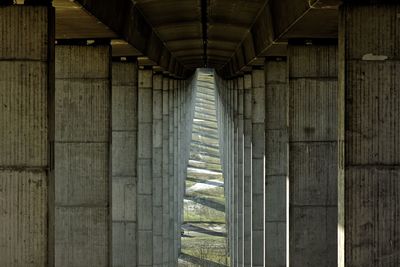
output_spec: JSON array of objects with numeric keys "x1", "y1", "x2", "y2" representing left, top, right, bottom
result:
[{"x1": 152, "y1": 74, "x2": 163, "y2": 267}]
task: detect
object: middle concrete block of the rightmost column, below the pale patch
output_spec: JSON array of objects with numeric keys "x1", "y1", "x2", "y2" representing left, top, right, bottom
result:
[{"x1": 346, "y1": 61, "x2": 400, "y2": 165}]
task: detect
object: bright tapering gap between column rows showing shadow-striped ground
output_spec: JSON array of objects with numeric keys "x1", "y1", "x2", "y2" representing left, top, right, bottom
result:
[{"x1": 179, "y1": 69, "x2": 229, "y2": 267}]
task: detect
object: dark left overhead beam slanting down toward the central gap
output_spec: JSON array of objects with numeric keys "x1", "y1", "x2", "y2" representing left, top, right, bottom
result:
[{"x1": 77, "y1": 0, "x2": 186, "y2": 78}]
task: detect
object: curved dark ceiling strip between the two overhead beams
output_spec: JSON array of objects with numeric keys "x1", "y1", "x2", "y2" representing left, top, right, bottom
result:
[{"x1": 136, "y1": 0, "x2": 266, "y2": 68}]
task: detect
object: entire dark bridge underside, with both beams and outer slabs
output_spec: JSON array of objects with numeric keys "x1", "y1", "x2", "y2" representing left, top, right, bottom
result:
[{"x1": 17, "y1": 0, "x2": 340, "y2": 77}]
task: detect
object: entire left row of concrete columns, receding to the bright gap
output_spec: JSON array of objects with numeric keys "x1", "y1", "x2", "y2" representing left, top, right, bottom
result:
[{"x1": 0, "y1": 6, "x2": 194, "y2": 267}]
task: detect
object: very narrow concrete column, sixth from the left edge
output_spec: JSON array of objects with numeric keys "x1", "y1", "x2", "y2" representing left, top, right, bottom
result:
[{"x1": 162, "y1": 77, "x2": 172, "y2": 266}]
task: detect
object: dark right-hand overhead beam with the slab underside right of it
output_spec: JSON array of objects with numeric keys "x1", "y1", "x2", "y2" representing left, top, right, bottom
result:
[{"x1": 218, "y1": 0, "x2": 341, "y2": 78}]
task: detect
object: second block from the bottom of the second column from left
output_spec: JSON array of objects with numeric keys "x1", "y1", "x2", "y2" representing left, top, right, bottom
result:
[{"x1": 54, "y1": 143, "x2": 109, "y2": 205}]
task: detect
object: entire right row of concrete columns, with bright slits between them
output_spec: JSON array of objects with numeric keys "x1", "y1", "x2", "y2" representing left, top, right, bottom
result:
[{"x1": 217, "y1": 5, "x2": 400, "y2": 267}]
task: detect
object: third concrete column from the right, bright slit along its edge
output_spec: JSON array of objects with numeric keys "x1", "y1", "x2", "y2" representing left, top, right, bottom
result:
[{"x1": 265, "y1": 58, "x2": 289, "y2": 267}]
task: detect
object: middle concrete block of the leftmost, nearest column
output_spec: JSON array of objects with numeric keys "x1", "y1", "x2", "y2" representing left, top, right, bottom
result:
[{"x1": 0, "y1": 62, "x2": 48, "y2": 167}]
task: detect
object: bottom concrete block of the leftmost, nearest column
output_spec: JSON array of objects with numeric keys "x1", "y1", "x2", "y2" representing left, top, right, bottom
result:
[{"x1": 0, "y1": 170, "x2": 48, "y2": 267}]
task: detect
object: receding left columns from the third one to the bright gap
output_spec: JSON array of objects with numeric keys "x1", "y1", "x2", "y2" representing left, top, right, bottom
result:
[{"x1": 112, "y1": 65, "x2": 194, "y2": 266}]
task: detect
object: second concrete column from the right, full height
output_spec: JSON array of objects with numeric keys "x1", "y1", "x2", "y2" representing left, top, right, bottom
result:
[{"x1": 288, "y1": 43, "x2": 338, "y2": 267}]
